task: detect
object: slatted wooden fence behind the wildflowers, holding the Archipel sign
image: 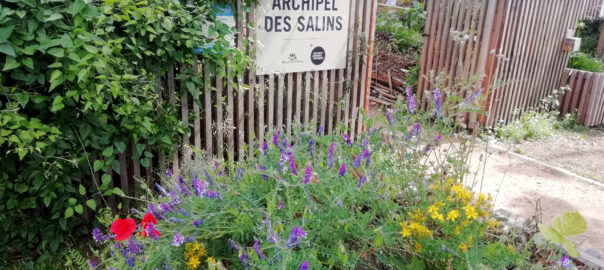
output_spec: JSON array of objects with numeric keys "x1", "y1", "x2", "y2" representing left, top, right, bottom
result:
[{"x1": 91, "y1": 0, "x2": 377, "y2": 210}]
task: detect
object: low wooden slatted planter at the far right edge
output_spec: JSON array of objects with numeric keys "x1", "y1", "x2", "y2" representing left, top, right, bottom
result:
[{"x1": 560, "y1": 69, "x2": 604, "y2": 126}]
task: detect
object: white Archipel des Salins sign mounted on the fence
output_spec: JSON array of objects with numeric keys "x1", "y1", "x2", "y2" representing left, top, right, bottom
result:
[{"x1": 256, "y1": 0, "x2": 350, "y2": 75}]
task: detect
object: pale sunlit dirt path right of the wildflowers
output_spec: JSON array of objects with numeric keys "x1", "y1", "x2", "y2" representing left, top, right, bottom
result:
[{"x1": 473, "y1": 143, "x2": 604, "y2": 255}]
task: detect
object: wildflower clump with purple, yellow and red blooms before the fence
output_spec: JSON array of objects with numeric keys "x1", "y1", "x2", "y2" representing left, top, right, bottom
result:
[{"x1": 88, "y1": 92, "x2": 532, "y2": 269}]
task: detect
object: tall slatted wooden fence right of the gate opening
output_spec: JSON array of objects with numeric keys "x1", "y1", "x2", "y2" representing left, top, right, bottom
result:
[{"x1": 418, "y1": 0, "x2": 600, "y2": 127}]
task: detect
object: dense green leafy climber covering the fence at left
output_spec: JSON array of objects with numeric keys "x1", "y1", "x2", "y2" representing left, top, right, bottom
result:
[{"x1": 0, "y1": 0, "x2": 248, "y2": 263}]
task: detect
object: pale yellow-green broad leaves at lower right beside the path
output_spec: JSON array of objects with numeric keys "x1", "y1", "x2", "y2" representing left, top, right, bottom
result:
[{"x1": 539, "y1": 211, "x2": 587, "y2": 257}]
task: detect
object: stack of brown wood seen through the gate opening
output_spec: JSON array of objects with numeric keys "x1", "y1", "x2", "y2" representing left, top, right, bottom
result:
[{"x1": 369, "y1": 71, "x2": 405, "y2": 107}]
